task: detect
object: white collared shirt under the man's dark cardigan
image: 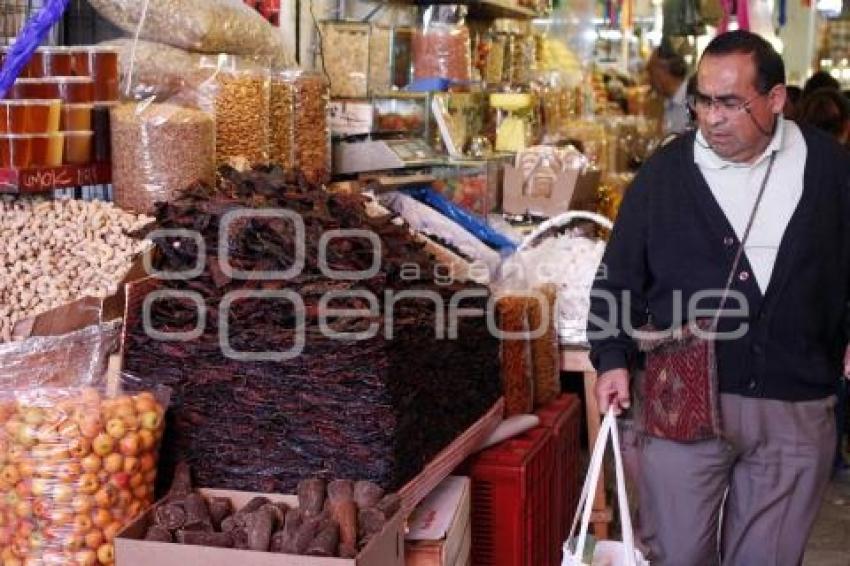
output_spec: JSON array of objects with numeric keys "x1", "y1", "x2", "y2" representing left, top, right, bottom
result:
[{"x1": 694, "y1": 116, "x2": 807, "y2": 293}]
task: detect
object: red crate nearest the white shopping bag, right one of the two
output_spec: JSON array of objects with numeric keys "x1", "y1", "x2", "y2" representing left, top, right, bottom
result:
[{"x1": 537, "y1": 394, "x2": 582, "y2": 563}]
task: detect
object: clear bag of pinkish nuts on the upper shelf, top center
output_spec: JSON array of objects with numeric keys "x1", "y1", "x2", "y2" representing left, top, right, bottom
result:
[{"x1": 413, "y1": 6, "x2": 472, "y2": 82}]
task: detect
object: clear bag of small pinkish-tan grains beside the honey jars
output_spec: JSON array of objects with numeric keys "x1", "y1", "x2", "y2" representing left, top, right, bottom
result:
[{"x1": 110, "y1": 100, "x2": 216, "y2": 213}]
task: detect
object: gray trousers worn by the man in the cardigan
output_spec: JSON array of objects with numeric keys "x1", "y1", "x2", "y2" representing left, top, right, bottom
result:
[{"x1": 635, "y1": 394, "x2": 835, "y2": 566}]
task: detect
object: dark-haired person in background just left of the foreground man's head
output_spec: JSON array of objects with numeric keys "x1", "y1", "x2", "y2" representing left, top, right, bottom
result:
[{"x1": 646, "y1": 43, "x2": 689, "y2": 136}]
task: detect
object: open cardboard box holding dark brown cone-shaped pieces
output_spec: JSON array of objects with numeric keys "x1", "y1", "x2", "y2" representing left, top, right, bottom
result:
[{"x1": 115, "y1": 489, "x2": 404, "y2": 566}]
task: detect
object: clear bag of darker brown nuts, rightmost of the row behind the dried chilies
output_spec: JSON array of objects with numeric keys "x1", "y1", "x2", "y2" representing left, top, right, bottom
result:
[{"x1": 270, "y1": 69, "x2": 331, "y2": 184}]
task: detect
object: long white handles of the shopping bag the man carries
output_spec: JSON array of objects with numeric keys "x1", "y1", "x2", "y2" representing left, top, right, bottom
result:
[{"x1": 567, "y1": 411, "x2": 636, "y2": 566}]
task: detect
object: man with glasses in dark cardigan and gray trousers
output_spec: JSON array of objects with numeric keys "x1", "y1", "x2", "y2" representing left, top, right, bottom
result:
[{"x1": 588, "y1": 31, "x2": 850, "y2": 566}]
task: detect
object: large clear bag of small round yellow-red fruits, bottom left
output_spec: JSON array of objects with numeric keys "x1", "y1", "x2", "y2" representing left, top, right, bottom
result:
[{"x1": 0, "y1": 330, "x2": 170, "y2": 566}]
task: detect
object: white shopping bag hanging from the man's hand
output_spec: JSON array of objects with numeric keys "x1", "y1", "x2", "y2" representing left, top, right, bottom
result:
[{"x1": 561, "y1": 411, "x2": 649, "y2": 566}]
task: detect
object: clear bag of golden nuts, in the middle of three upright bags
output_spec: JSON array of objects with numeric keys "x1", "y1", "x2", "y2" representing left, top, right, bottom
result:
[{"x1": 198, "y1": 54, "x2": 271, "y2": 165}]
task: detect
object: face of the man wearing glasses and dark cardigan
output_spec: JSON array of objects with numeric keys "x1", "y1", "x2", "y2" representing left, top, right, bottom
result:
[{"x1": 695, "y1": 53, "x2": 785, "y2": 163}]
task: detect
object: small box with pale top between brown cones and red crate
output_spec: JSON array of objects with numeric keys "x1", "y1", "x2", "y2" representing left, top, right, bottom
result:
[{"x1": 404, "y1": 476, "x2": 472, "y2": 566}]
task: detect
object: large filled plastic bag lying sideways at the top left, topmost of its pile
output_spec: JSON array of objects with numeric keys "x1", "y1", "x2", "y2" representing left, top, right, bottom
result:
[{"x1": 89, "y1": 0, "x2": 293, "y2": 66}]
